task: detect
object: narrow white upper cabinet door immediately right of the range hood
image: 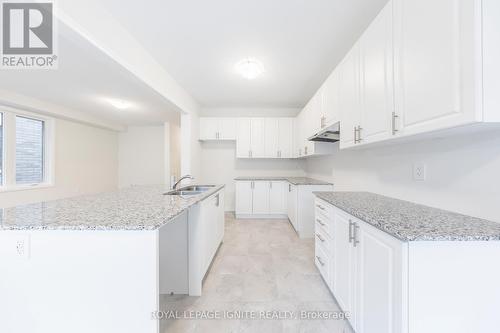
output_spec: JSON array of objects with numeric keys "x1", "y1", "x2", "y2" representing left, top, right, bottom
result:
[{"x1": 339, "y1": 44, "x2": 361, "y2": 148}]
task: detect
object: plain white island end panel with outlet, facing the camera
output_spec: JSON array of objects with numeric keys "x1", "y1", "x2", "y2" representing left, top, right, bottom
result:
[{"x1": 0, "y1": 230, "x2": 159, "y2": 333}]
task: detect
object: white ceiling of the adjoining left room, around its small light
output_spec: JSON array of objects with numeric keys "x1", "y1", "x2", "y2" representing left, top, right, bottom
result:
[{"x1": 0, "y1": 23, "x2": 179, "y2": 126}]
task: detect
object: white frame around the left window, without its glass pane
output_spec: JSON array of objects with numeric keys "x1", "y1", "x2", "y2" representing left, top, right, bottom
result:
[{"x1": 0, "y1": 106, "x2": 55, "y2": 192}]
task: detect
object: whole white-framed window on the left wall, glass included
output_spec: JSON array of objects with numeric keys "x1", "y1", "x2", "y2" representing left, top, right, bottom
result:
[{"x1": 0, "y1": 108, "x2": 53, "y2": 191}]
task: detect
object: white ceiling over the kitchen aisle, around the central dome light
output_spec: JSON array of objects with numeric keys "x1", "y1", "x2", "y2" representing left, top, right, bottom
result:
[{"x1": 101, "y1": 0, "x2": 387, "y2": 107}]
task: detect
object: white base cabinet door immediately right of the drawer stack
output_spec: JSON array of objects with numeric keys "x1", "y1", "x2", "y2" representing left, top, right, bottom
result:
[{"x1": 333, "y1": 209, "x2": 356, "y2": 329}]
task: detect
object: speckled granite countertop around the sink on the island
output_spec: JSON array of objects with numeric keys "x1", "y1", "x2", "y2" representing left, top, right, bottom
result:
[{"x1": 0, "y1": 185, "x2": 224, "y2": 230}]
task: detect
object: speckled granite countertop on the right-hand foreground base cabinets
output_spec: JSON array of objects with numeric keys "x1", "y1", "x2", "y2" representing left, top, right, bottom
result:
[{"x1": 314, "y1": 192, "x2": 500, "y2": 241}]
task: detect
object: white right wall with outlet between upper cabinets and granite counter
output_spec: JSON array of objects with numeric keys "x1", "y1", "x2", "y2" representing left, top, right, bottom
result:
[{"x1": 305, "y1": 133, "x2": 500, "y2": 222}]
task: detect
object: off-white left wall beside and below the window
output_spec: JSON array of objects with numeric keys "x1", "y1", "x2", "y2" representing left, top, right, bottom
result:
[{"x1": 0, "y1": 119, "x2": 118, "y2": 208}]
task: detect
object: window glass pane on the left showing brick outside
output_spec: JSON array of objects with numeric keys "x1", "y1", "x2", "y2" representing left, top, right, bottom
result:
[{"x1": 16, "y1": 116, "x2": 45, "y2": 184}]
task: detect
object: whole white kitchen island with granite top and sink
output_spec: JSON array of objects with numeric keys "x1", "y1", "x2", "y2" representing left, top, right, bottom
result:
[{"x1": 0, "y1": 186, "x2": 224, "y2": 333}]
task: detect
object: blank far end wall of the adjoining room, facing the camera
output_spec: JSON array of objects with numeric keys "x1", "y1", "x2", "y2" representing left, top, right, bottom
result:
[{"x1": 118, "y1": 125, "x2": 169, "y2": 188}]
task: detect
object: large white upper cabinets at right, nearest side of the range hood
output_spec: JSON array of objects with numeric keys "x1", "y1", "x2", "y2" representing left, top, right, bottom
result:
[{"x1": 332, "y1": 0, "x2": 500, "y2": 148}]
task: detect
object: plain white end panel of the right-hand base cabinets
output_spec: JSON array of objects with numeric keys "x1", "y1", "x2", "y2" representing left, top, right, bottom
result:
[{"x1": 408, "y1": 241, "x2": 500, "y2": 333}]
